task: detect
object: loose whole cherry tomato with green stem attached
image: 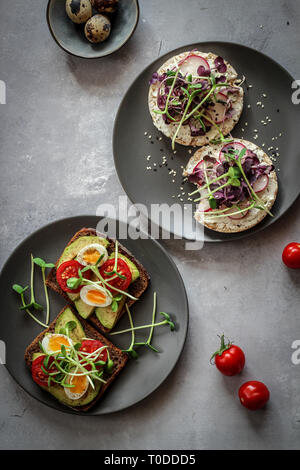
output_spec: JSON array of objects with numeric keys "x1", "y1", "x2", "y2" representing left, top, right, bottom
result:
[{"x1": 211, "y1": 335, "x2": 245, "y2": 376}]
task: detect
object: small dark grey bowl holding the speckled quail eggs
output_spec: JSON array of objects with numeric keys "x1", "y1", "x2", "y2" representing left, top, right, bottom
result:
[{"x1": 47, "y1": 0, "x2": 139, "y2": 59}]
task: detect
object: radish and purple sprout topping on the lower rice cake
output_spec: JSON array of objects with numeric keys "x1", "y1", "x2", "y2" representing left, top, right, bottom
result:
[{"x1": 188, "y1": 142, "x2": 274, "y2": 220}]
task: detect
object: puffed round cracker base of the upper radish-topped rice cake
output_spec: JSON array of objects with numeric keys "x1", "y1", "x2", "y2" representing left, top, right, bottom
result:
[{"x1": 148, "y1": 51, "x2": 244, "y2": 147}]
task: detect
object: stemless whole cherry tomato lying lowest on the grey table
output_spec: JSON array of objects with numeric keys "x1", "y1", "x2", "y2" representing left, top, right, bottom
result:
[{"x1": 239, "y1": 380, "x2": 270, "y2": 411}]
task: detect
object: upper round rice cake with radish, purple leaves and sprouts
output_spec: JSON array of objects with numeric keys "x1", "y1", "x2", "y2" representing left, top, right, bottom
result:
[{"x1": 148, "y1": 50, "x2": 243, "y2": 148}]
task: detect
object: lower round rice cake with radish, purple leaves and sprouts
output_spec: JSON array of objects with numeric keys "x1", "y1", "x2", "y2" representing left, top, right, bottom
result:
[{"x1": 183, "y1": 139, "x2": 278, "y2": 232}]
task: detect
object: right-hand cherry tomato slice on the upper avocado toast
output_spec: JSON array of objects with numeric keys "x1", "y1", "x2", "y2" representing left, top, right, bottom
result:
[{"x1": 100, "y1": 258, "x2": 132, "y2": 294}]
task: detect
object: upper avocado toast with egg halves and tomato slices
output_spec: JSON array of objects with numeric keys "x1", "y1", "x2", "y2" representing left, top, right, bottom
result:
[{"x1": 46, "y1": 228, "x2": 150, "y2": 332}]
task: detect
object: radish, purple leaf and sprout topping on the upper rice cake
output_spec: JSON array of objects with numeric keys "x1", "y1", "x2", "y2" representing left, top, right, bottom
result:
[{"x1": 150, "y1": 52, "x2": 242, "y2": 149}]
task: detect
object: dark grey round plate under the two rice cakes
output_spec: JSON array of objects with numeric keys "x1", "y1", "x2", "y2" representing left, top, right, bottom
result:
[{"x1": 113, "y1": 42, "x2": 300, "y2": 242}]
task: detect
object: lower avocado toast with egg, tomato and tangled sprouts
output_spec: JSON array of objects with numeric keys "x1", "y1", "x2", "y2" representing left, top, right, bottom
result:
[{"x1": 25, "y1": 306, "x2": 128, "y2": 411}]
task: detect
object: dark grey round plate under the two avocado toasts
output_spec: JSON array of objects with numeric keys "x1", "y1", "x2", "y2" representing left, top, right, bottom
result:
[{"x1": 0, "y1": 216, "x2": 188, "y2": 415}]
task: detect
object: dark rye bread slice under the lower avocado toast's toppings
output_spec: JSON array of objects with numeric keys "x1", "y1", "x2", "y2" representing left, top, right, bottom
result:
[{"x1": 24, "y1": 305, "x2": 128, "y2": 411}]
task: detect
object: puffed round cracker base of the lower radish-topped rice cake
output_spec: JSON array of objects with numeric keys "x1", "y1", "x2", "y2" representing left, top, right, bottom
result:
[{"x1": 183, "y1": 139, "x2": 278, "y2": 233}]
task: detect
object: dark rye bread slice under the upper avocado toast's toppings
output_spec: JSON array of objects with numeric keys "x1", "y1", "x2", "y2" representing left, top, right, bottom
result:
[{"x1": 46, "y1": 228, "x2": 150, "y2": 333}]
